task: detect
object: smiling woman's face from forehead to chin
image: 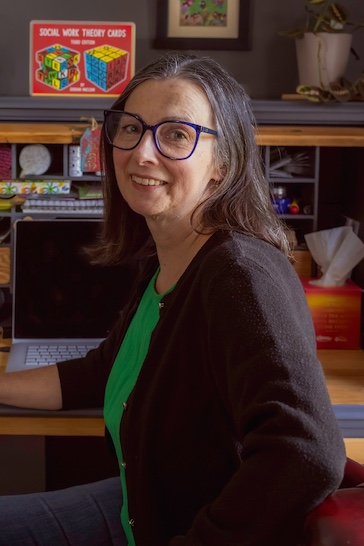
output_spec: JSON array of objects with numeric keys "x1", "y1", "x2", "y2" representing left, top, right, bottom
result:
[{"x1": 113, "y1": 79, "x2": 219, "y2": 225}]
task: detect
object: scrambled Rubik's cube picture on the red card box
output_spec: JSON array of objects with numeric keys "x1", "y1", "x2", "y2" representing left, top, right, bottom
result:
[{"x1": 36, "y1": 44, "x2": 80, "y2": 90}]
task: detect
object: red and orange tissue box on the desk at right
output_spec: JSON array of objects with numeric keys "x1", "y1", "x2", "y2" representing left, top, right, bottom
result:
[{"x1": 301, "y1": 279, "x2": 361, "y2": 349}]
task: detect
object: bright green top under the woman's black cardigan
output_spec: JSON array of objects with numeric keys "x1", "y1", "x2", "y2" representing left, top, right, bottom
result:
[{"x1": 104, "y1": 269, "x2": 174, "y2": 546}]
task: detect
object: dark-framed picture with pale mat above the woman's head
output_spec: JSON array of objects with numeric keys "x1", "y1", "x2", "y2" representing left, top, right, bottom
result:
[{"x1": 154, "y1": 0, "x2": 252, "y2": 50}]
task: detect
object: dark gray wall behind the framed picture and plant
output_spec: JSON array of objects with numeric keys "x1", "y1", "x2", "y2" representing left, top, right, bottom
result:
[{"x1": 0, "y1": 0, "x2": 364, "y2": 100}]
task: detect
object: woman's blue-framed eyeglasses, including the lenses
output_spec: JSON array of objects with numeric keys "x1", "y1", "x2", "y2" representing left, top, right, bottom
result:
[{"x1": 104, "y1": 110, "x2": 218, "y2": 160}]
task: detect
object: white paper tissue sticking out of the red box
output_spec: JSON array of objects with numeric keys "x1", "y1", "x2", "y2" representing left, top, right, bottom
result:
[{"x1": 305, "y1": 226, "x2": 364, "y2": 286}]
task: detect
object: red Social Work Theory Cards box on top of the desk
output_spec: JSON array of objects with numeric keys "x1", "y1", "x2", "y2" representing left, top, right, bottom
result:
[{"x1": 29, "y1": 20, "x2": 135, "y2": 97}]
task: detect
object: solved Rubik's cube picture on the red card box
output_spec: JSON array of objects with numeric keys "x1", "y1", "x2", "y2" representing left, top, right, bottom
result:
[{"x1": 84, "y1": 45, "x2": 129, "y2": 91}]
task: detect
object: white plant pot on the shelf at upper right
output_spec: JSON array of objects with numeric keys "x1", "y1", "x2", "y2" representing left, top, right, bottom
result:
[{"x1": 296, "y1": 32, "x2": 352, "y2": 87}]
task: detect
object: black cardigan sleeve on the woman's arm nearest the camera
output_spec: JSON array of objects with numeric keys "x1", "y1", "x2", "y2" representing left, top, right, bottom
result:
[{"x1": 170, "y1": 241, "x2": 346, "y2": 546}]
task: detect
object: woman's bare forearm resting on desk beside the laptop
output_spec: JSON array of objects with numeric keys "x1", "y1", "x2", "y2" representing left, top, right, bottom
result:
[{"x1": 0, "y1": 366, "x2": 62, "y2": 410}]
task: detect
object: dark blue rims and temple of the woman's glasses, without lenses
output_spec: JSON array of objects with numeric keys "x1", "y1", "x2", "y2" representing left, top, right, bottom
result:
[{"x1": 104, "y1": 109, "x2": 219, "y2": 161}]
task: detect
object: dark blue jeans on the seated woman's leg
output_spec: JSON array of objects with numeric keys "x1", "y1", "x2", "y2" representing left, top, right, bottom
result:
[{"x1": 0, "y1": 477, "x2": 127, "y2": 546}]
